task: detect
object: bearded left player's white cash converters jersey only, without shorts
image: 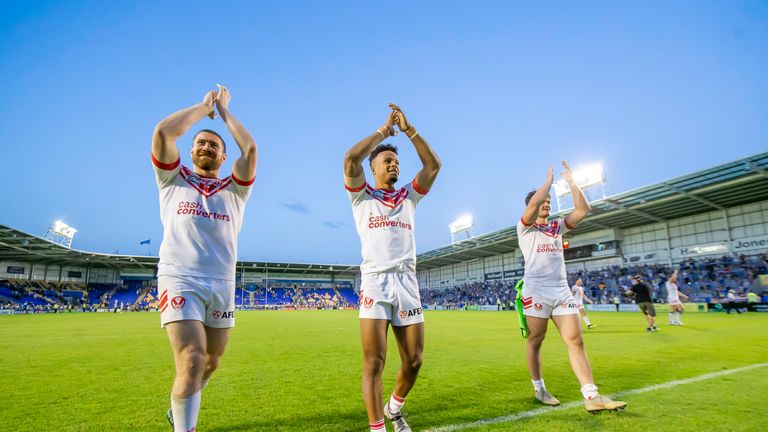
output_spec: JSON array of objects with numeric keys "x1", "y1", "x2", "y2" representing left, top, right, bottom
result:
[{"x1": 152, "y1": 155, "x2": 255, "y2": 280}]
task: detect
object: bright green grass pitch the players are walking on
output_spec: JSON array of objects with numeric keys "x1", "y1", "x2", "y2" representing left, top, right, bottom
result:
[{"x1": 0, "y1": 311, "x2": 768, "y2": 432}]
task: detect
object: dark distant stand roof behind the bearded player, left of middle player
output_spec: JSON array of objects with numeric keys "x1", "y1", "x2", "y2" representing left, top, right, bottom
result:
[{"x1": 0, "y1": 225, "x2": 359, "y2": 276}]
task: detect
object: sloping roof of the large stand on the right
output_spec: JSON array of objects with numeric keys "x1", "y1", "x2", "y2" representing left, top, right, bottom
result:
[{"x1": 418, "y1": 152, "x2": 768, "y2": 270}]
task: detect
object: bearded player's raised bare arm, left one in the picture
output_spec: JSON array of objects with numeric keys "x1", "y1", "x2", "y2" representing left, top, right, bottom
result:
[{"x1": 152, "y1": 91, "x2": 218, "y2": 164}]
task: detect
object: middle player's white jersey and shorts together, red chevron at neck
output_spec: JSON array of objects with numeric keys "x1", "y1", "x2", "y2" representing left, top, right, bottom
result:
[{"x1": 347, "y1": 181, "x2": 427, "y2": 326}]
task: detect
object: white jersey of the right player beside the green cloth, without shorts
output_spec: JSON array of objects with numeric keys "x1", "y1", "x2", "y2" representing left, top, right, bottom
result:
[{"x1": 517, "y1": 218, "x2": 571, "y2": 289}]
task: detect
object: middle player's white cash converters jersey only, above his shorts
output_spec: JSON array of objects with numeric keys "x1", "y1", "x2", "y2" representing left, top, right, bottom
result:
[{"x1": 345, "y1": 180, "x2": 428, "y2": 275}]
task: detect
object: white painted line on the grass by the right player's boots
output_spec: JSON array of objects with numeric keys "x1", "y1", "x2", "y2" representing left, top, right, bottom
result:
[{"x1": 424, "y1": 363, "x2": 768, "y2": 432}]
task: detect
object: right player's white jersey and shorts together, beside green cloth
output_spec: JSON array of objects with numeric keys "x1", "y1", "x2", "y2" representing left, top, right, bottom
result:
[{"x1": 517, "y1": 218, "x2": 579, "y2": 318}]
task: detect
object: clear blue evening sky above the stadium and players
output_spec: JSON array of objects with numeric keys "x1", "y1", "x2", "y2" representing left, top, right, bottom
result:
[{"x1": 0, "y1": 0, "x2": 768, "y2": 264}]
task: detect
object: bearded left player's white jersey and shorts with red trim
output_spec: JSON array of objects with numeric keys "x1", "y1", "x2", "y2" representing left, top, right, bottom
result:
[{"x1": 152, "y1": 156, "x2": 254, "y2": 328}]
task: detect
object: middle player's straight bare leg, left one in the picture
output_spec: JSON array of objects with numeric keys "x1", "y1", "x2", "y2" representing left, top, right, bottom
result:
[{"x1": 360, "y1": 318, "x2": 389, "y2": 423}]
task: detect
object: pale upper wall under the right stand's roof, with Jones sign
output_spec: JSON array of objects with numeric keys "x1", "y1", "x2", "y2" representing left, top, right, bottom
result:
[{"x1": 418, "y1": 200, "x2": 768, "y2": 289}]
